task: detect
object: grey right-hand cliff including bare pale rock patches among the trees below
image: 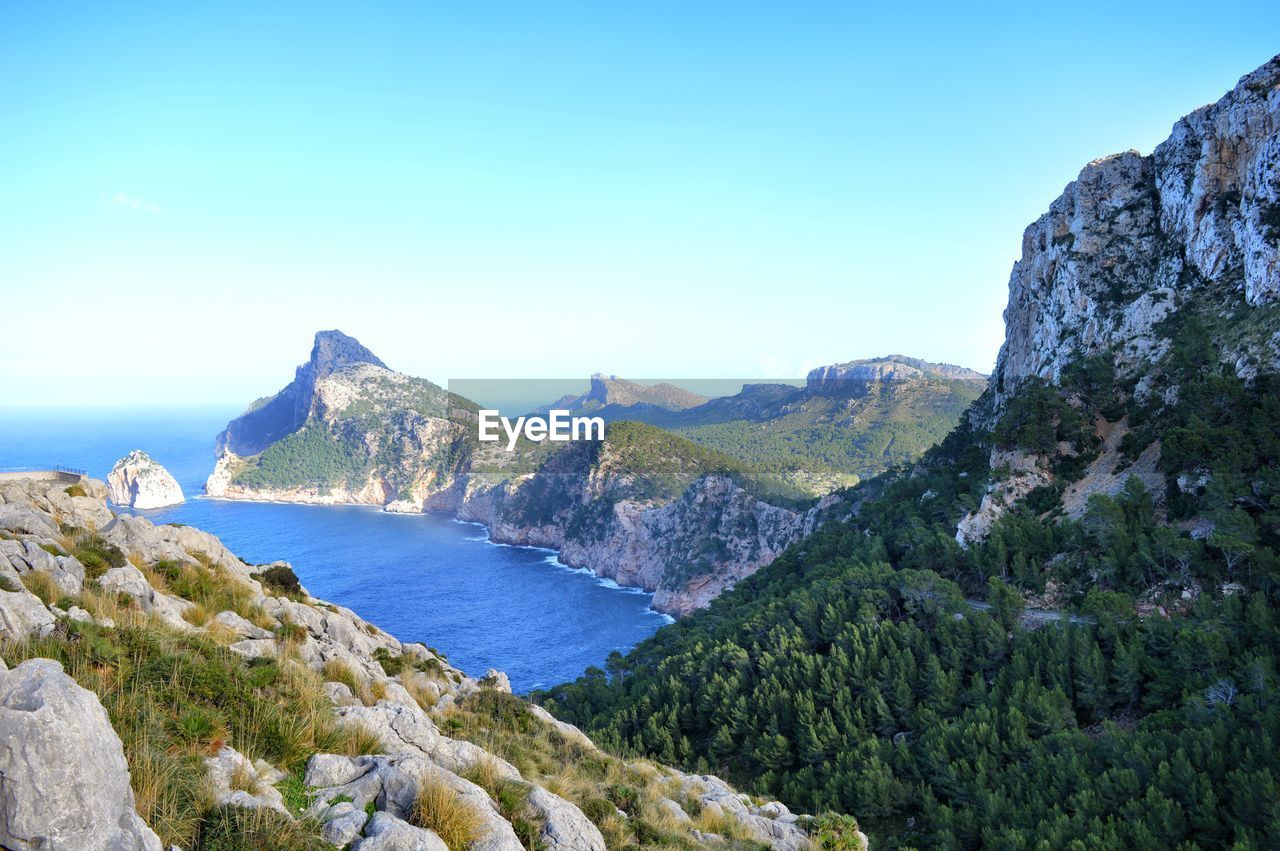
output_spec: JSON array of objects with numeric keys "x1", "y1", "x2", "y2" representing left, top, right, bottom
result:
[{"x1": 956, "y1": 56, "x2": 1280, "y2": 544}]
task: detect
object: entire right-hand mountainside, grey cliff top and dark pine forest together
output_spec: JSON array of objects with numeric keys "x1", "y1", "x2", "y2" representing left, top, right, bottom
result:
[{"x1": 538, "y1": 56, "x2": 1280, "y2": 848}]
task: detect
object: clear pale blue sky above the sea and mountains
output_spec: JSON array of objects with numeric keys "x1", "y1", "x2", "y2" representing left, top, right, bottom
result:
[{"x1": 0, "y1": 0, "x2": 1280, "y2": 404}]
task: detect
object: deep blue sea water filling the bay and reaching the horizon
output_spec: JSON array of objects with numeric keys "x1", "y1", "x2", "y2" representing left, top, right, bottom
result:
[{"x1": 0, "y1": 408, "x2": 669, "y2": 691}]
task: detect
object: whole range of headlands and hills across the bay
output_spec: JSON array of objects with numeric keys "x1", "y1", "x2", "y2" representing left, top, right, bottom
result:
[{"x1": 206, "y1": 330, "x2": 984, "y2": 614}]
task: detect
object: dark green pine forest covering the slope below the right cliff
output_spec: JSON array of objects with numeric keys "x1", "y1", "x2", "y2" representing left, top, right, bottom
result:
[{"x1": 540, "y1": 330, "x2": 1280, "y2": 847}]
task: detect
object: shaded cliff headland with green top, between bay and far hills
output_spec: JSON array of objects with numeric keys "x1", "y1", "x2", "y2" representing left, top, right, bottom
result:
[{"x1": 460, "y1": 421, "x2": 832, "y2": 616}]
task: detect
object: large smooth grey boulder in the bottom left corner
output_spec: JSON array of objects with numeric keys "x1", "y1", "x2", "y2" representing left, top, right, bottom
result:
[{"x1": 0, "y1": 659, "x2": 161, "y2": 851}]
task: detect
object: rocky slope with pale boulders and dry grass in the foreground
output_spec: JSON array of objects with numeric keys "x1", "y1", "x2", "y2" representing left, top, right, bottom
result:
[{"x1": 0, "y1": 480, "x2": 829, "y2": 851}]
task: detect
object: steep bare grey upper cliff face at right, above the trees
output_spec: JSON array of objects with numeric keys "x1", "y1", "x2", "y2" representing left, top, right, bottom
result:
[{"x1": 993, "y1": 56, "x2": 1280, "y2": 398}]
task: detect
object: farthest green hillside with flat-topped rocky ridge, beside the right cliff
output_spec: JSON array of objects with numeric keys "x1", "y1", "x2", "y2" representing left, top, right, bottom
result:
[{"x1": 545, "y1": 354, "x2": 987, "y2": 497}]
